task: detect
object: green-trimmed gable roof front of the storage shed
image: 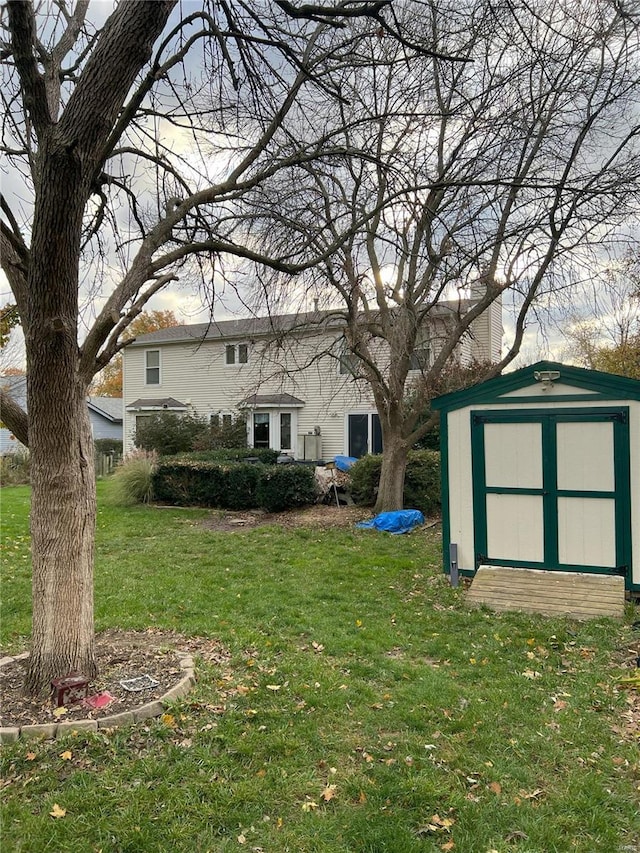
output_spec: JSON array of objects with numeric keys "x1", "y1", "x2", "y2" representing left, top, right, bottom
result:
[{"x1": 431, "y1": 361, "x2": 640, "y2": 411}]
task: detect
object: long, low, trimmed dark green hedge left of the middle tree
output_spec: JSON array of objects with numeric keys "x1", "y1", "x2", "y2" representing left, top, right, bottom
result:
[{"x1": 153, "y1": 459, "x2": 316, "y2": 512}]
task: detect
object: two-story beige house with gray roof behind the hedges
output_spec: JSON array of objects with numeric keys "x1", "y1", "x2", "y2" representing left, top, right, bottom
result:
[{"x1": 123, "y1": 301, "x2": 502, "y2": 460}]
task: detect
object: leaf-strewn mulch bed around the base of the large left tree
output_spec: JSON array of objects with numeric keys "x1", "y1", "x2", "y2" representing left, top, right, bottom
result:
[{"x1": 0, "y1": 629, "x2": 229, "y2": 727}]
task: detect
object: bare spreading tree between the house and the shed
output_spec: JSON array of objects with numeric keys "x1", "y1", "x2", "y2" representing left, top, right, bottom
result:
[{"x1": 242, "y1": 0, "x2": 640, "y2": 510}]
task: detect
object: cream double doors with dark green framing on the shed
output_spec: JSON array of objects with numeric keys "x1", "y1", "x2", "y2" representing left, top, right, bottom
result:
[{"x1": 472, "y1": 409, "x2": 630, "y2": 574}]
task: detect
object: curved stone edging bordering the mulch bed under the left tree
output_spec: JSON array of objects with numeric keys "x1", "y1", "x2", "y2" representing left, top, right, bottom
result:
[{"x1": 0, "y1": 652, "x2": 196, "y2": 744}]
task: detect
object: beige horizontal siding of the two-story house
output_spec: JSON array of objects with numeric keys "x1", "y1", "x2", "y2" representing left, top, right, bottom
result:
[{"x1": 123, "y1": 303, "x2": 499, "y2": 459}]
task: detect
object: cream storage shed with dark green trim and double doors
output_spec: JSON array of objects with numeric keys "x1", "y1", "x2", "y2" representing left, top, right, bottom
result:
[{"x1": 433, "y1": 361, "x2": 640, "y2": 595}]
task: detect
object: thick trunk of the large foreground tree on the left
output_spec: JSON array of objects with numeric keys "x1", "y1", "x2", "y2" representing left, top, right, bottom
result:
[{"x1": 25, "y1": 139, "x2": 97, "y2": 696}]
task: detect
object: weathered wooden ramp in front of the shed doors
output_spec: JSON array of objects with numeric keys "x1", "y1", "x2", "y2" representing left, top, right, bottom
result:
[{"x1": 467, "y1": 566, "x2": 624, "y2": 619}]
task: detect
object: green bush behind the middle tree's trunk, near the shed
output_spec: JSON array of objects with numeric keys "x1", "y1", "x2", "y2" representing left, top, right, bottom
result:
[{"x1": 349, "y1": 450, "x2": 440, "y2": 515}]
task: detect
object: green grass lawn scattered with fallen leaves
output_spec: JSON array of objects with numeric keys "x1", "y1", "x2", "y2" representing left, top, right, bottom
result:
[{"x1": 1, "y1": 488, "x2": 640, "y2": 853}]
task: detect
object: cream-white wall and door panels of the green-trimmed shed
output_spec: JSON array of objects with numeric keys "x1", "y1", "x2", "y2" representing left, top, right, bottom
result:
[{"x1": 436, "y1": 365, "x2": 640, "y2": 589}]
